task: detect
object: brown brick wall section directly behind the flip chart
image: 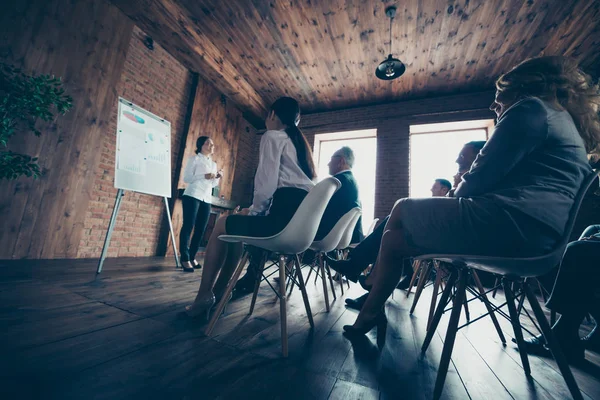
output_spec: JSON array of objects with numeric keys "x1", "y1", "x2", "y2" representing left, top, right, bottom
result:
[{"x1": 77, "y1": 27, "x2": 192, "y2": 258}]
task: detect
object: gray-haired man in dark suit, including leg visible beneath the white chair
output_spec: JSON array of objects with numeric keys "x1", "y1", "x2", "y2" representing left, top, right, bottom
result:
[{"x1": 233, "y1": 146, "x2": 364, "y2": 297}]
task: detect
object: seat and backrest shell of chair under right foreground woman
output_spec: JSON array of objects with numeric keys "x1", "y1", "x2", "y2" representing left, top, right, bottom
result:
[{"x1": 416, "y1": 171, "x2": 598, "y2": 277}]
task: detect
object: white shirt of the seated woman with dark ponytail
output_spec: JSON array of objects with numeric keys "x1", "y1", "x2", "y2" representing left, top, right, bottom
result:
[{"x1": 250, "y1": 131, "x2": 315, "y2": 215}]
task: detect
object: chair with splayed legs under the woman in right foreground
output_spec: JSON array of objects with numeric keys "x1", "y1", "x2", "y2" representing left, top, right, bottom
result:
[{"x1": 416, "y1": 172, "x2": 598, "y2": 399}]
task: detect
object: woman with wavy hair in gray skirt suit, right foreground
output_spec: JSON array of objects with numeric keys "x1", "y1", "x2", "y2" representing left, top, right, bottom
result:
[{"x1": 332, "y1": 57, "x2": 600, "y2": 334}]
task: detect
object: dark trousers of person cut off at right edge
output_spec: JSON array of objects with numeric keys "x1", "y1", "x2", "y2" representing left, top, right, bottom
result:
[{"x1": 546, "y1": 225, "x2": 600, "y2": 318}]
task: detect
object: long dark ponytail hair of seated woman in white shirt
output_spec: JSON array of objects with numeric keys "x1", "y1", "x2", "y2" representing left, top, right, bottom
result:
[{"x1": 271, "y1": 97, "x2": 317, "y2": 179}]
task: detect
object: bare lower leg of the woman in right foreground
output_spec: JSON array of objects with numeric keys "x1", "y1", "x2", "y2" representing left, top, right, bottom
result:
[{"x1": 354, "y1": 202, "x2": 419, "y2": 328}]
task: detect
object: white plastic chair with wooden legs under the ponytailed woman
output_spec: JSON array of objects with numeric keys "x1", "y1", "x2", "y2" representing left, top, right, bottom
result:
[{"x1": 205, "y1": 177, "x2": 341, "y2": 357}]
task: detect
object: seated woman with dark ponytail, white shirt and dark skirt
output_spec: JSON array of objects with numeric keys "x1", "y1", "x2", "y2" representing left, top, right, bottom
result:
[{"x1": 186, "y1": 97, "x2": 317, "y2": 317}]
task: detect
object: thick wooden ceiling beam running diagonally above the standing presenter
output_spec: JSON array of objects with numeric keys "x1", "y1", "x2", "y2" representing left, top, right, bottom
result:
[{"x1": 111, "y1": 0, "x2": 267, "y2": 125}]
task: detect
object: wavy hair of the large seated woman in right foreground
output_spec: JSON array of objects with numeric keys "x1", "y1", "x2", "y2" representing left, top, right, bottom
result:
[{"x1": 496, "y1": 56, "x2": 600, "y2": 154}]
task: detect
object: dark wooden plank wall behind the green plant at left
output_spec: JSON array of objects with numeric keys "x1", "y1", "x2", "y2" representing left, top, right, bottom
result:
[{"x1": 0, "y1": 0, "x2": 133, "y2": 258}]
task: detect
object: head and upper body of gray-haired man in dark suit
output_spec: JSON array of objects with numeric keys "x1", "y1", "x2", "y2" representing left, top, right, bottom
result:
[{"x1": 315, "y1": 146, "x2": 364, "y2": 243}]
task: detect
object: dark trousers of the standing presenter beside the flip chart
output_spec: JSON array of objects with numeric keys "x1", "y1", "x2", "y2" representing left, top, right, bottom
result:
[{"x1": 179, "y1": 196, "x2": 210, "y2": 262}]
